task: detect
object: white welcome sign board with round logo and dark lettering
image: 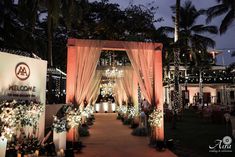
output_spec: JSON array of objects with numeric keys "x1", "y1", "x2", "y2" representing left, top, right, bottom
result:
[{"x1": 0, "y1": 52, "x2": 47, "y2": 137}]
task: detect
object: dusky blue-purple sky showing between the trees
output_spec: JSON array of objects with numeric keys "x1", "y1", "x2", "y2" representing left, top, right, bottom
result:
[{"x1": 90, "y1": 0, "x2": 235, "y2": 65}]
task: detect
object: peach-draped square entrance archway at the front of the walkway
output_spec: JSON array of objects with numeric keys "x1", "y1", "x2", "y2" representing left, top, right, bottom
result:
[{"x1": 66, "y1": 38, "x2": 164, "y2": 140}]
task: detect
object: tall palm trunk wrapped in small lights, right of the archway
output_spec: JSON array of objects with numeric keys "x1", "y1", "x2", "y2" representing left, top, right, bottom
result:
[{"x1": 172, "y1": 0, "x2": 180, "y2": 129}]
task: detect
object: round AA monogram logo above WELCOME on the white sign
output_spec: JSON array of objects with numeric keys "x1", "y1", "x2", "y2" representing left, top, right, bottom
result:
[{"x1": 15, "y1": 62, "x2": 30, "y2": 81}]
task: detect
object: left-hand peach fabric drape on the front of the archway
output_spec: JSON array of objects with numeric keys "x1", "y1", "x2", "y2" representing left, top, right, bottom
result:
[{"x1": 75, "y1": 40, "x2": 102, "y2": 105}]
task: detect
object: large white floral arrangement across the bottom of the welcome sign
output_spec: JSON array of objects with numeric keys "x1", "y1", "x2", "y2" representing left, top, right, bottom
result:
[{"x1": 0, "y1": 100, "x2": 44, "y2": 139}]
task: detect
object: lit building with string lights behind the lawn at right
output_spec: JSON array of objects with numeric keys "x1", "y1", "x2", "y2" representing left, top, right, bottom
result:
[{"x1": 163, "y1": 65, "x2": 235, "y2": 107}]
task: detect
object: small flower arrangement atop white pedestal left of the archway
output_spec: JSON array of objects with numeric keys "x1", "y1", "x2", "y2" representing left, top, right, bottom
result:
[{"x1": 52, "y1": 116, "x2": 67, "y2": 133}]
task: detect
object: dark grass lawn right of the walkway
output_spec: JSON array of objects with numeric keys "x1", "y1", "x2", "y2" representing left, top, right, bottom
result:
[{"x1": 165, "y1": 110, "x2": 235, "y2": 157}]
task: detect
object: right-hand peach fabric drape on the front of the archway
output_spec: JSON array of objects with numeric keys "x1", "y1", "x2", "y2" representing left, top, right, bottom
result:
[{"x1": 123, "y1": 42, "x2": 156, "y2": 104}]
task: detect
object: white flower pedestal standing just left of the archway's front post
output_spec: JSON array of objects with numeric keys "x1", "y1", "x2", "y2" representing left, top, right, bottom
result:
[{"x1": 53, "y1": 131, "x2": 66, "y2": 152}]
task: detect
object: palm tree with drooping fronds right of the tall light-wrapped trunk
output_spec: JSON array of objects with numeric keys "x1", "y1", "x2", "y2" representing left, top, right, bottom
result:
[{"x1": 175, "y1": 1, "x2": 218, "y2": 111}]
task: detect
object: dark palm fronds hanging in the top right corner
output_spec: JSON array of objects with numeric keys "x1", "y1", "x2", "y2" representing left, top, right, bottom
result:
[{"x1": 207, "y1": 0, "x2": 235, "y2": 34}]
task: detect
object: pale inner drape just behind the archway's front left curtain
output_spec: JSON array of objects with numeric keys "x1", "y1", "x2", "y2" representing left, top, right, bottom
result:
[{"x1": 86, "y1": 70, "x2": 102, "y2": 105}]
